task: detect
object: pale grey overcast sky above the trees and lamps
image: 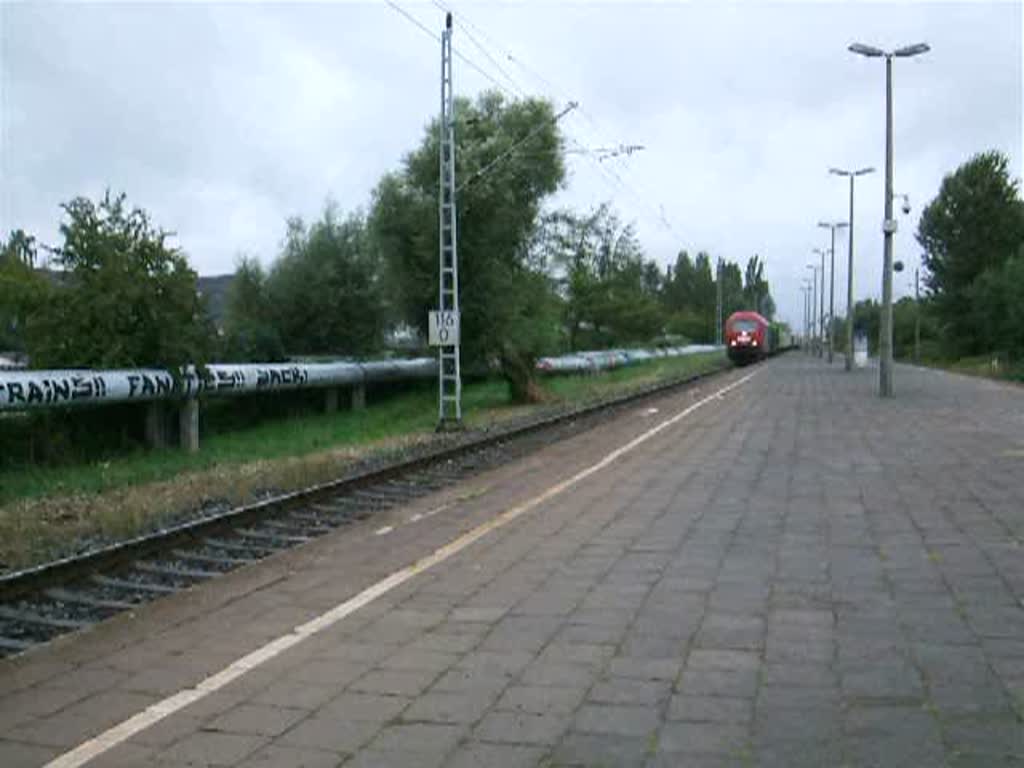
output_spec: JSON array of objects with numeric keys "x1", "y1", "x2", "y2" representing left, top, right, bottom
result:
[{"x1": 0, "y1": 0, "x2": 1024, "y2": 331}]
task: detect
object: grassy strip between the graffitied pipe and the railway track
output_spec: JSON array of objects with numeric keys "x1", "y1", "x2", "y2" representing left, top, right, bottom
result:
[{"x1": 0, "y1": 353, "x2": 724, "y2": 569}]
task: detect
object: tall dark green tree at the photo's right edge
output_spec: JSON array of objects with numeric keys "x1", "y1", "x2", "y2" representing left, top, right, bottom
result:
[{"x1": 916, "y1": 152, "x2": 1024, "y2": 354}]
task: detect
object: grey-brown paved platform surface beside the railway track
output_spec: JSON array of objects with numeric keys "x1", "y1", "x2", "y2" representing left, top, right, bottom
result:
[{"x1": 0, "y1": 353, "x2": 1024, "y2": 768}]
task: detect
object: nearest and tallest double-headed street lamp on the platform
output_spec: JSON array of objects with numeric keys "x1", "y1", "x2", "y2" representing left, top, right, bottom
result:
[{"x1": 849, "y1": 43, "x2": 931, "y2": 397}]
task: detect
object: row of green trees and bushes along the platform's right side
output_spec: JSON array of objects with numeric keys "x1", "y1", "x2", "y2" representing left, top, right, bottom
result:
[{"x1": 839, "y1": 152, "x2": 1024, "y2": 367}]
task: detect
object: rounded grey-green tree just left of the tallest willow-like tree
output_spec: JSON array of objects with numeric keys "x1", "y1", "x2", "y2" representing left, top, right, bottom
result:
[{"x1": 266, "y1": 202, "x2": 388, "y2": 355}]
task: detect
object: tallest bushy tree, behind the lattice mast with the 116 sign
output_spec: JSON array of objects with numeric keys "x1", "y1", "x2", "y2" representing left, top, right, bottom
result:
[{"x1": 370, "y1": 92, "x2": 565, "y2": 400}]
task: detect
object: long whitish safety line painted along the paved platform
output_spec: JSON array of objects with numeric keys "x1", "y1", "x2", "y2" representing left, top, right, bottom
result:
[{"x1": 43, "y1": 371, "x2": 757, "y2": 768}]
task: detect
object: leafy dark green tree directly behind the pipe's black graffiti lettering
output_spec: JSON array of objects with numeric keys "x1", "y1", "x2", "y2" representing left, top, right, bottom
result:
[{"x1": 27, "y1": 191, "x2": 211, "y2": 374}]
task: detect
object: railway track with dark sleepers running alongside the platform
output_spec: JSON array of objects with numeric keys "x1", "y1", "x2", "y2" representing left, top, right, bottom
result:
[{"x1": 0, "y1": 365, "x2": 728, "y2": 657}]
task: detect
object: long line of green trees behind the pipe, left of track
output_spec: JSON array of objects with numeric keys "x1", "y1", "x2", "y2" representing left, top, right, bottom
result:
[{"x1": 0, "y1": 93, "x2": 774, "y2": 399}]
